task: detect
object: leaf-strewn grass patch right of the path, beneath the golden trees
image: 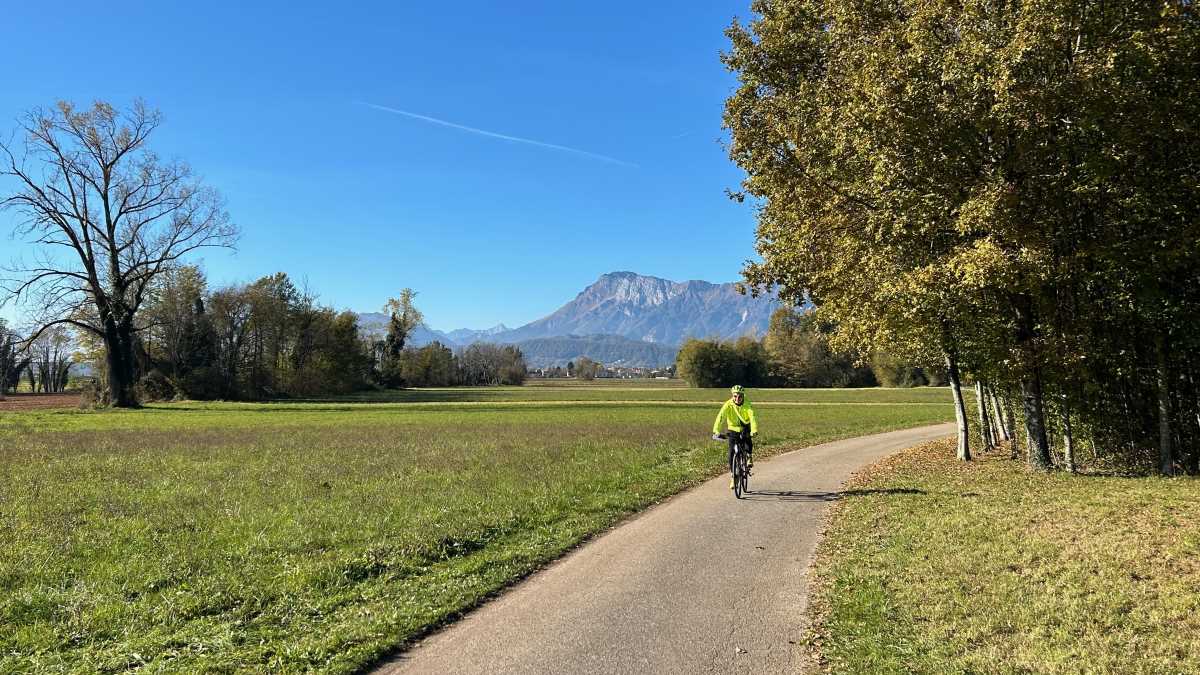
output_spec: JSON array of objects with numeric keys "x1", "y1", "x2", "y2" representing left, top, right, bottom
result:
[{"x1": 814, "y1": 441, "x2": 1200, "y2": 674}]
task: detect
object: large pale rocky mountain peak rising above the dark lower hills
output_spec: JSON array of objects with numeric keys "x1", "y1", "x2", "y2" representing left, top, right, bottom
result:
[{"x1": 490, "y1": 271, "x2": 780, "y2": 345}]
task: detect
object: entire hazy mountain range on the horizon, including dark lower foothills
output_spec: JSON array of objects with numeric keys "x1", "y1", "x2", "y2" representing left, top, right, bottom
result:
[{"x1": 359, "y1": 271, "x2": 780, "y2": 366}]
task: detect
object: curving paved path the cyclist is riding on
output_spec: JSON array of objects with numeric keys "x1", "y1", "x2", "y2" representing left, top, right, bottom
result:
[{"x1": 379, "y1": 424, "x2": 954, "y2": 675}]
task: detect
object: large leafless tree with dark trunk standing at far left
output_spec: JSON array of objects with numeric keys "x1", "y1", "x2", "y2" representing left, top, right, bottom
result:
[{"x1": 0, "y1": 101, "x2": 236, "y2": 407}]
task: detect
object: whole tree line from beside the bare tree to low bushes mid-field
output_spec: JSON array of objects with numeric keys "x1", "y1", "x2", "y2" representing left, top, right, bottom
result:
[{"x1": 132, "y1": 267, "x2": 526, "y2": 400}]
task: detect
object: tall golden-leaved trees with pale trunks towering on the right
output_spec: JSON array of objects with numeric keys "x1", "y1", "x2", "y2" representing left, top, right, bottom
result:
[{"x1": 724, "y1": 0, "x2": 1200, "y2": 474}]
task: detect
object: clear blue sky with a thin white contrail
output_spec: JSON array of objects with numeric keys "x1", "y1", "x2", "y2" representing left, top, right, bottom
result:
[{"x1": 0, "y1": 0, "x2": 754, "y2": 329}]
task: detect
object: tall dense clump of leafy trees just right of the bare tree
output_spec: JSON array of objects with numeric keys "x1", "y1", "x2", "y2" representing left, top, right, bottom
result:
[{"x1": 136, "y1": 267, "x2": 373, "y2": 399}]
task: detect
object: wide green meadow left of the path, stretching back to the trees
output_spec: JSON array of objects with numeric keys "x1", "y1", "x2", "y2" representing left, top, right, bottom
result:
[{"x1": 0, "y1": 386, "x2": 953, "y2": 673}]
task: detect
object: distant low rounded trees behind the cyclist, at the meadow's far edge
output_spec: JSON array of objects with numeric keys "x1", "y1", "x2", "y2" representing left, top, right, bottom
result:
[{"x1": 676, "y1": 307, "x2": 946, "y2": 388}]
